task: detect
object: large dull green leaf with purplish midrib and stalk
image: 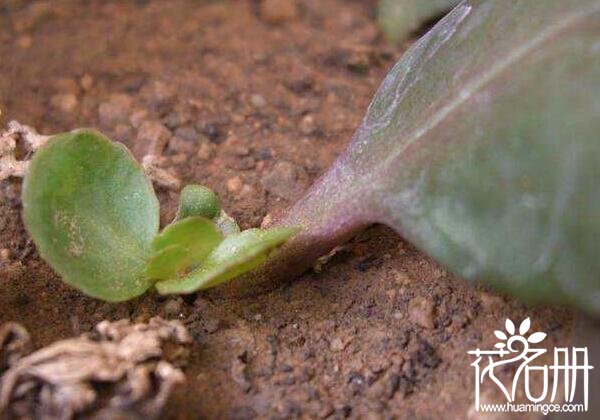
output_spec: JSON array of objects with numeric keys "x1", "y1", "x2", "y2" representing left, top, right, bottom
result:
[{"x1": 267, "y1": 0, "x2": 600, "y2": 314}]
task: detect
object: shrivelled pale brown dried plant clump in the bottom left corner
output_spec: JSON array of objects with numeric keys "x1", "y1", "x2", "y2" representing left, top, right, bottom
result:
[{"x1": 0, "y1": 317, "x2": 191, "y2": 419}]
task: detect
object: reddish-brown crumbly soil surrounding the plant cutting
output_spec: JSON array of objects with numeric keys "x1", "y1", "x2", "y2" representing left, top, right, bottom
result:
[{"x1": 0, "y1": 0, "x2": 573, "y2": 418}]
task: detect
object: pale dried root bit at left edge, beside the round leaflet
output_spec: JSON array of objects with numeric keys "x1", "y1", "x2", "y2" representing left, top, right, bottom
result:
[{"x1": 0, "y1": 121, "x2": 50, "y2": 181}]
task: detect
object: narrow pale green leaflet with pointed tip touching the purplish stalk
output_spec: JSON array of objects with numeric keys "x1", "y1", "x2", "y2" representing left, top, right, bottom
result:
[{"x1": 156, "y1": 228, "x2": 298, "y2": 294}]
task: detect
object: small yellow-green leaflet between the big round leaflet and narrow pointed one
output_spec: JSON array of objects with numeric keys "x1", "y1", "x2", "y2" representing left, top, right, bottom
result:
[{"x1": 146, "y1": 216, "x2": 223, "y2": 279}]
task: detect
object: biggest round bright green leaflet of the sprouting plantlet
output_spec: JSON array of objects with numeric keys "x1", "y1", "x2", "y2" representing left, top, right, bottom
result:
[{"x1": 23, "y1": 130, "x2": 159, "y2": 301}]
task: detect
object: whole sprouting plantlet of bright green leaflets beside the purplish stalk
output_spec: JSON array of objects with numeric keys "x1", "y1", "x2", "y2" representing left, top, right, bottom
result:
[{"x1": 23, "y1": 130, "x2": 297, "y2": 301}]
